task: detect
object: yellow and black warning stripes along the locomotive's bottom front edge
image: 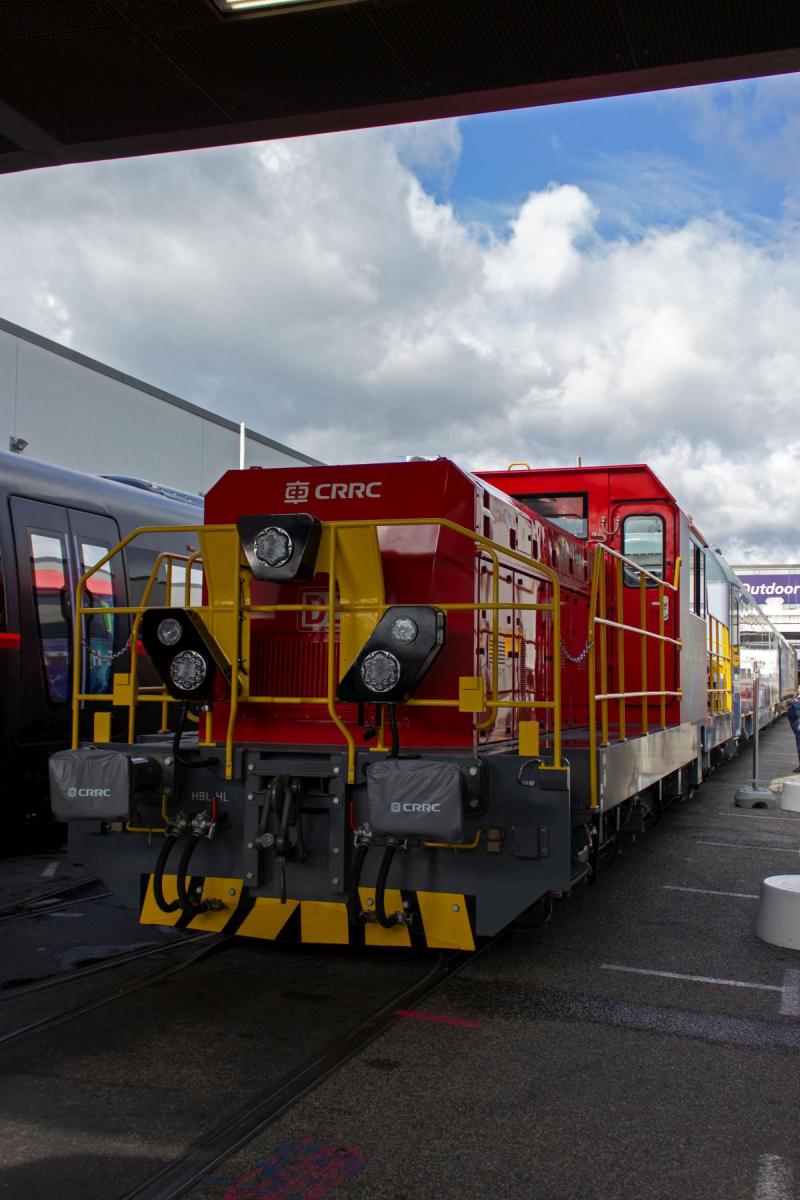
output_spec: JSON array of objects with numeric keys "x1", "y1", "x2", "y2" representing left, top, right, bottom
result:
[{"x1": 139, "y1": 875, "x2": 475, "y2": 950}]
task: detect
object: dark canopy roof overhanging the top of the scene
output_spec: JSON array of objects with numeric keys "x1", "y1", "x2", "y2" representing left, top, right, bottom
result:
[{"x1": 0, "y1": 0, "x2": 800, "y2": 172}]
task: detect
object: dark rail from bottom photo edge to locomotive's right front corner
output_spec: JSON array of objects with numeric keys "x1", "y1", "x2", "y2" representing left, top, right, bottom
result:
[{"x1": 120, "y1": 935, "x2": 503, "y2": 1200}]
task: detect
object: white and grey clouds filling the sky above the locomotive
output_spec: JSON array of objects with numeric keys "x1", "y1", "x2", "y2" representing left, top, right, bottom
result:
[{"x1": 0, "y1": 122, "x2": 800, "y2": 558}]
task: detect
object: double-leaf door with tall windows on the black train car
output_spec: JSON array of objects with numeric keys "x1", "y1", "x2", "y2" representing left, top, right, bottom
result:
[{"x1": 10, "y1": 497, "x2": 125, "y2": 745}]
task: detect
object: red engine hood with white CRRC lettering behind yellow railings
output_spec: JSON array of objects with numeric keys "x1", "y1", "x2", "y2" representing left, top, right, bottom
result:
[{"x1": 205, "y1": 458, "x2": 589, "y2": 748}]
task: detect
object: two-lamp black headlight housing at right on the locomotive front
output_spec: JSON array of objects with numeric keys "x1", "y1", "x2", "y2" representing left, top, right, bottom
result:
[{"x1": 337, "y1": 605, "x2": 446, "y2": 704}]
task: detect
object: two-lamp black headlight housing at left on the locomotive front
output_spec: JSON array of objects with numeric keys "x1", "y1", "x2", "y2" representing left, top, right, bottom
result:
[{"x1": 140, "y1": 608, "x2": 231, "y2": 701}]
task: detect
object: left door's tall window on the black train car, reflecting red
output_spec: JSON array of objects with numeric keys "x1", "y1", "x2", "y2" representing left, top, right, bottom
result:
[{"x1": 29, "y1": 533, "x2": 70, "y2": 704}]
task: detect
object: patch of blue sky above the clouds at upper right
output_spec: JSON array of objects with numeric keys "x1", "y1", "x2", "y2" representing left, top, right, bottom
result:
[{"x1": 431, "y1": 76, "x2": 800, "y2": 233}]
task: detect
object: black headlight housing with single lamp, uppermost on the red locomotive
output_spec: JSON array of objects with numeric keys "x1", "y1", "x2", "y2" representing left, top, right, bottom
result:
[{"x1": 236, "y1": 512, "x2": 323, "y2": 583}]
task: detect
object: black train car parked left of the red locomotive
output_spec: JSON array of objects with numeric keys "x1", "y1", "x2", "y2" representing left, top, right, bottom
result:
[{"x1": 0, "y1": 451, "x2": 201, "y2": 854}]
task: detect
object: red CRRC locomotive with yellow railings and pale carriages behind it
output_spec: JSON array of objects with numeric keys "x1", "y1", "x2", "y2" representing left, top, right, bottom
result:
[{"x1": 52, "y1": 458, "x2": 794, "y2": 948}]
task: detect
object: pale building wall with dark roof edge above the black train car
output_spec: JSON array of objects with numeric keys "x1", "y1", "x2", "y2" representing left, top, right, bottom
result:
[{"x1": 0, "y1": 319, "x2": 315, "y2": 492}]
